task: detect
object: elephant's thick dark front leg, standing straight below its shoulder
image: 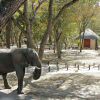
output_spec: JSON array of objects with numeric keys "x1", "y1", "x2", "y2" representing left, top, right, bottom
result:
[{"x1": 16, "y1": 67, "x2": 25, "y2": 94}]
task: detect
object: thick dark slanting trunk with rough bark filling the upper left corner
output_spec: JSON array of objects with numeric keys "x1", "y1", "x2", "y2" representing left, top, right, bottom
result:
[{"x1": 0, "y1": 0, "x2": 25, "y2": 31}]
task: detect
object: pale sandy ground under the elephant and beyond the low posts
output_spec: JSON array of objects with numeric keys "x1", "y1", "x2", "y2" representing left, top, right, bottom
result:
[{"x1": 0, "y1": 50, "x2": 100, "y2": 100}]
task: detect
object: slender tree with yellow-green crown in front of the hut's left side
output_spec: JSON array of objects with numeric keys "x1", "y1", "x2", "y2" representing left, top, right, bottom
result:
[{"x1": 73, "y1": 0, "x2": 97, "y2": 52}]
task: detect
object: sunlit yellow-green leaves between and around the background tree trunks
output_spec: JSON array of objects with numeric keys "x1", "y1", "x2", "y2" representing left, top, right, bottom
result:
[{"x1": 8, "y1": 0, "x2": 100, "y2": 47}]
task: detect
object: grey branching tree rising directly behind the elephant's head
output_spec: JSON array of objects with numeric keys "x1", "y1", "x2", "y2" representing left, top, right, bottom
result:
[{"x1": 13, "y1": 0, "x2": 46, "y2": 49}]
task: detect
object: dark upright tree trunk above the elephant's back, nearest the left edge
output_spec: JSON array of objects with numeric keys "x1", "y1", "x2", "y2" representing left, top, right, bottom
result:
[{"x1": 6, "y1": 19, "x2": 12, "y2": 49}]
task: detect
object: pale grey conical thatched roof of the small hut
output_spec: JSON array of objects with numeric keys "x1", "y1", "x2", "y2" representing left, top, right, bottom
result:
[{"x1": 76, "y1": 28, "x2": 99, "y2": 39}]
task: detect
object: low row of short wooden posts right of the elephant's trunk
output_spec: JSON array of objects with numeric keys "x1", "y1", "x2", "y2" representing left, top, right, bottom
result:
[{"x1": 43, "y1": 61, "x2": 100, "y2": 72}]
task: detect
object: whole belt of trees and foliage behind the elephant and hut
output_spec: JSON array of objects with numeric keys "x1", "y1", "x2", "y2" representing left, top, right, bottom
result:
[{"x1": 0, "y1": 0, "x2": 100, "y2": 60}]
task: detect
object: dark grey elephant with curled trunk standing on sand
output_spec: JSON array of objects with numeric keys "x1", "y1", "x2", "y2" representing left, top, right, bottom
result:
[{"x1": 0, "y1": 48, "x2": 41, "y2": 94}]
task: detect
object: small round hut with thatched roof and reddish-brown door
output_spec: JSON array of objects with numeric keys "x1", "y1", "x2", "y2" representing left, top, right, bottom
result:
[{"x1": 76, "y1": 28, "x2": 99, "y2": 49}]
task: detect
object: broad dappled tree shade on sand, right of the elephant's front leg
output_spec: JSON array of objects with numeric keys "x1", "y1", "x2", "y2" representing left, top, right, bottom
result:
[{"x1": 27, "y1": 73, "x2": 100, "y2": 100}]
